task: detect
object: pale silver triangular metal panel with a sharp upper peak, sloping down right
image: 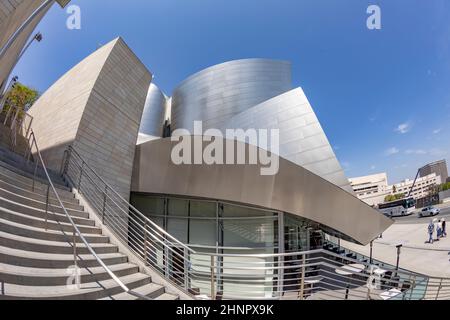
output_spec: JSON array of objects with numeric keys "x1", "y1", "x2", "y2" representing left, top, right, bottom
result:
[{"x1": 221, "y1": 88, "x2": 354, "y2": 194}]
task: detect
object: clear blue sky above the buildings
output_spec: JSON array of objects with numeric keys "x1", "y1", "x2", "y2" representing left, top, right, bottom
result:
[{"x1": 10, "y1": 0, "x2": 450, "y2": 182}]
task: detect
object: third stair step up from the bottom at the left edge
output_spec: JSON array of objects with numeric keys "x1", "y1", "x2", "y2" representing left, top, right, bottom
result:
[{"x1": 0, "y1": 246, "x2": 128, "y2": 269}]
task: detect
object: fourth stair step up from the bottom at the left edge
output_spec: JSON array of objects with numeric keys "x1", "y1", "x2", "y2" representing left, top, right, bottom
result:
[{"x1": 0, "y1": 231, "x2": 119, "y2": 254}]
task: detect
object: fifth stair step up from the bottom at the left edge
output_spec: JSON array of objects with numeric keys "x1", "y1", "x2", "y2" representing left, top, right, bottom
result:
[{"x1": 0, "y1": 218, "x2": 109, "y2": 244}]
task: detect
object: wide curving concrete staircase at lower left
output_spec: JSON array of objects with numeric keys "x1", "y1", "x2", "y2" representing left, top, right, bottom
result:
[{"x1": 0, "y1": 150, "x2": 178, "y2": 300}]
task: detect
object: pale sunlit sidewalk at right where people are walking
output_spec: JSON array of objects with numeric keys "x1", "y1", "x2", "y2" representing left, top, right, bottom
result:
[{"x1": 341, "y1": 221, "x2": 450, "y2": 278}]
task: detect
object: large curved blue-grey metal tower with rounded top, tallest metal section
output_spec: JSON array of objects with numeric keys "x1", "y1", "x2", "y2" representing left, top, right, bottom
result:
[{"x1": 171, "y1": 59, "x2": 292, "y2": 132}]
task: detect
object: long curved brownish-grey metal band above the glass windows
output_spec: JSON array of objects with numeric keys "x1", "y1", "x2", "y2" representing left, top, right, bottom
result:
[{"x1": 131, "y1": 138, "x2": 393, "y2": 245}]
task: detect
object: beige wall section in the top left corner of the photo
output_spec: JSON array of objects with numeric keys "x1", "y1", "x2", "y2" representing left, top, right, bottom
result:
[{"x1": 0, "y1": 0, "x2": 50, "y2": 88}]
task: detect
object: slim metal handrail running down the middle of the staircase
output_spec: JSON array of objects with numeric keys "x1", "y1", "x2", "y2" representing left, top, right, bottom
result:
[{"x1": 25, "y1": 129, "x2": 150, "y2": 300}]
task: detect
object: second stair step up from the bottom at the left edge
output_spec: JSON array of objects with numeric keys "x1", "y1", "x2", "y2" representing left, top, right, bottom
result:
[{"x1": 0, "y1": 263, "x2": 139, "y2": 286}]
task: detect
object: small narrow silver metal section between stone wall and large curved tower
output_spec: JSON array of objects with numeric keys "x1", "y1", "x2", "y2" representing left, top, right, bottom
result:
[{"x1": 139, "y1": 83, "x2": 168, "y2": 138}]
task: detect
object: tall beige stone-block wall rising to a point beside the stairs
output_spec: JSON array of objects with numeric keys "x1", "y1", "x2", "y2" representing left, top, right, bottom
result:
[{"x1": 30, "y1": 38, "x2": 151, "y2": 199}]
